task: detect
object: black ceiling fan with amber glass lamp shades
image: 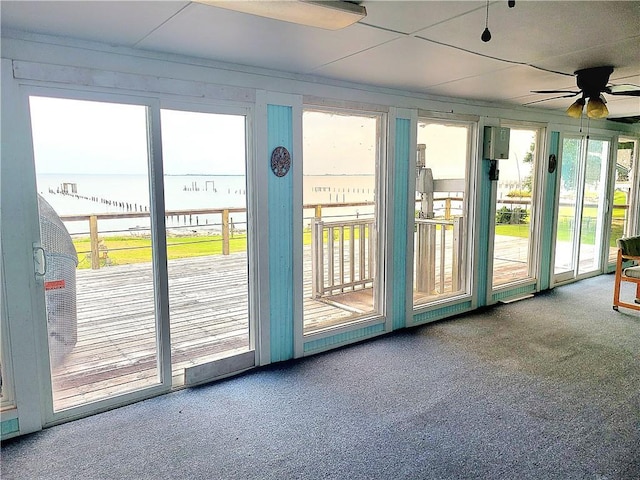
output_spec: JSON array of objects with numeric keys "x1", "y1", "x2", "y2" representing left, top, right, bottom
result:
[{"x1": 532, "y1": 67, "x2": 640, "y2": 118}]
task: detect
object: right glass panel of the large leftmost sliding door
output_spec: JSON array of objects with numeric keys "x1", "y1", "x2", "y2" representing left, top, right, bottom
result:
[{"x1": 161, "y1": 110, "x2": 250, "y2": 385}]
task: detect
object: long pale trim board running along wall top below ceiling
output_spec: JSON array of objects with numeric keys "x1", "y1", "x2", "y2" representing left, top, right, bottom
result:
[{"x1": 2, "y1": 30, "x2": 638, "y2": 132}]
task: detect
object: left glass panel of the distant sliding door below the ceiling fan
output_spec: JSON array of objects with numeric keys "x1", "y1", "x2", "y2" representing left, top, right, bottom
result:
[{"x1": 554, "y1": 137, "x2": 582, "y2": 277}]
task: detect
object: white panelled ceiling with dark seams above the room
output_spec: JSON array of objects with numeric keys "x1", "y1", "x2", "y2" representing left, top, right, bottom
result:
[{"x1": 0, "y1": 0, "x2": 640, "y2": 117}]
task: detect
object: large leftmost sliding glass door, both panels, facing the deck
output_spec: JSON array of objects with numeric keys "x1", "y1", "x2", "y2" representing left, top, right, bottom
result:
[{"x1": 28, "y1": 96, "x2": 255, "y2": 420}]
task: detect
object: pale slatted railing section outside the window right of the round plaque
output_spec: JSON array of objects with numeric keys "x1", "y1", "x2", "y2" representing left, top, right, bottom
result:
[{"x1": 311, "y1": 217, "x2": 376, "y2": 298}]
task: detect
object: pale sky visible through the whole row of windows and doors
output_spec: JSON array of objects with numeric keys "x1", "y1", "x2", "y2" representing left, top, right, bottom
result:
[{"x1": 30, "y1": 97, "x2": 532, "y2": 180}]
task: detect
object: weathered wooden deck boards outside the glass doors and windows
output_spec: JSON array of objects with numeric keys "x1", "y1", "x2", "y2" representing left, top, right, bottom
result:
[{"x1": 52, "y1": 235, "x2": 540, "y2": 411}]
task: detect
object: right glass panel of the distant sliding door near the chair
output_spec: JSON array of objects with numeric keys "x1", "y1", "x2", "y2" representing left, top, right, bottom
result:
[{"x1": 578, "y1": 139, "x2": 609, "y2": 275}]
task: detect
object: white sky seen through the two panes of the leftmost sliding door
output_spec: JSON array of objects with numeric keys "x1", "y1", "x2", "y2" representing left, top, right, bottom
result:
[{"x1": 30, "y1": 97, "x2": 245, "y2": 175}]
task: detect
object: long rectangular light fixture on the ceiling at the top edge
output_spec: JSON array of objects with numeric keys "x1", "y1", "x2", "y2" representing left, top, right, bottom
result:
[{"x1": 200, "y1": 0, "x2": 367, "y2": 30}]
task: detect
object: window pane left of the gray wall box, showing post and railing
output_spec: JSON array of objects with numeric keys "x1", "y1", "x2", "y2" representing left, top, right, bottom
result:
[{"x1": 413, "y1": 120, "x2": 471, "y2": 306}]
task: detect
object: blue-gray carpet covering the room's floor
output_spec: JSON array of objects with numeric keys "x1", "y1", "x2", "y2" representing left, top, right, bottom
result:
[{"x1": 1, "y1": 275, "x2": 640, "y2": 480}]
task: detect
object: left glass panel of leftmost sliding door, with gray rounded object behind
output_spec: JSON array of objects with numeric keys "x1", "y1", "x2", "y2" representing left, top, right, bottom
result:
[{"x1": 29, "y1": 97, "x2": 160, "y2": 412}]
